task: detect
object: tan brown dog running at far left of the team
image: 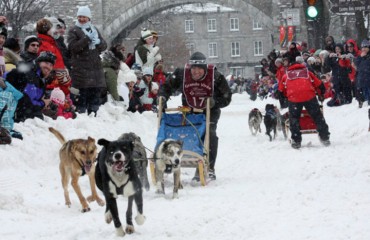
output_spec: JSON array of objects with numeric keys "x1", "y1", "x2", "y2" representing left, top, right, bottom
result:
[{"x1": 49, "y1": 127, "x2": 105, "y2": 212}]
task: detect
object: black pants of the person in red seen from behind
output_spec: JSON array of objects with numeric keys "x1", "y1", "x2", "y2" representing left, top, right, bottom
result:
[{"x1": 288, "y1": 97, "x2": 330, "y2": 143}]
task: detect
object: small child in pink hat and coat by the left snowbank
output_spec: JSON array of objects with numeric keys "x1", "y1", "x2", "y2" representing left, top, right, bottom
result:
[{"x1": 50, "y1": 88, "x2": 76, "y2": 119}]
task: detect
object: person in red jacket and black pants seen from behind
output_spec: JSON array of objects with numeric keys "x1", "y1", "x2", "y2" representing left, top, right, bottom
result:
[{"x1": 279, "y1": 59, "x2": 330, "y2": 149}]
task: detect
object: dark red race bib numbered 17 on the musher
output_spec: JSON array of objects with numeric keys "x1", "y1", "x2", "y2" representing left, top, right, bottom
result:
[{"x1": 183, "y1": 64, "x2": 215, "y2": 109}]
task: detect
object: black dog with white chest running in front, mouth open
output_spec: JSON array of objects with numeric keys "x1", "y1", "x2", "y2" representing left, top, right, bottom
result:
[{"x1": 95, "y1": 139, "x2": 145, "y2": 236}]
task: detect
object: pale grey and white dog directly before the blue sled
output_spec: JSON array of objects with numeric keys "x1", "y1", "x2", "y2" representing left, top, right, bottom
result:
[{"x1": 154, "y1": 139, "x2": 183, "y2": 198}]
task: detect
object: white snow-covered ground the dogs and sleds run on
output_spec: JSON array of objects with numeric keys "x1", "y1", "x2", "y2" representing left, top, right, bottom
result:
[{"x1": 0, "y1": 93, "x2": 370, "y2": 240}]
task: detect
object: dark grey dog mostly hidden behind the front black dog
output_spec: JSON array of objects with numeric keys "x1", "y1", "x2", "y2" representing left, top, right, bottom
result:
[{"x1": 118, "y1": 132, "x2": 150, "y2": 191}]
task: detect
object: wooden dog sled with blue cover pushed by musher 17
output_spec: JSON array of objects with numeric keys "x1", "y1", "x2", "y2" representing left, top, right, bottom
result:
[{"x1": 150, "y1": 97, "x2": 210, "y2": 186}]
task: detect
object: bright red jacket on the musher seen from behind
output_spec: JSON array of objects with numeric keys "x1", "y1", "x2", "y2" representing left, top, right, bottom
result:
[{"x1": 279, "y1": 63, "x2": 324, "y2": 102}]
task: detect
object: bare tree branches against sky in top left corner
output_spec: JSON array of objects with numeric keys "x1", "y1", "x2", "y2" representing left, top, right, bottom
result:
[{"x1": 0, "y1": 0, "x2": 50, "y2": 37}]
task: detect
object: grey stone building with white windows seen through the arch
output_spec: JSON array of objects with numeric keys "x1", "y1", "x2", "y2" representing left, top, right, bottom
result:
[{"x1": 125, "y1": 4, "x2": 274, "y2": 77}]
